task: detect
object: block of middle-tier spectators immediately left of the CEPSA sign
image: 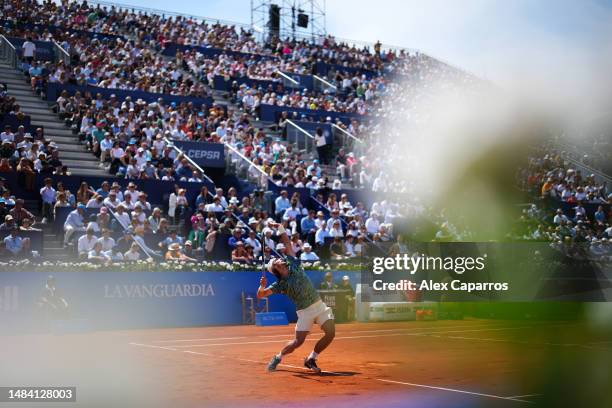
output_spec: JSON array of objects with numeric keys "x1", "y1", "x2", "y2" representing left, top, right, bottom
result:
[{"x1": 56, "y1": 92, "x2": 230, "y2": 177}]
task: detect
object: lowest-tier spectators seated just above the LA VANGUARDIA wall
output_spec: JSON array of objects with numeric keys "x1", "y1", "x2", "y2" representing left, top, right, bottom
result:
[{"x1": 31, "y1": 174, "x2": 403, "y2": 264}]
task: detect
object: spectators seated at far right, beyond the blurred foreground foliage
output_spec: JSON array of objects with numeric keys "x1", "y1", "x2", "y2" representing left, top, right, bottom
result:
[{"x1": 518, "y1": 147, "x2": 612, "y2": 262}]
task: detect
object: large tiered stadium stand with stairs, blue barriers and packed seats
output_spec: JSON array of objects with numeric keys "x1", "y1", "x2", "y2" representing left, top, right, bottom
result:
[{"x1": 0, "y1": 1, "x2": 610, "y2": 264}]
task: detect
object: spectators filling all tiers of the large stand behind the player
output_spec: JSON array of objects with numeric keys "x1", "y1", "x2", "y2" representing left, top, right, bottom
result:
[{"x1": 3, "y1": 1, "x2": 488, "y2": 263}]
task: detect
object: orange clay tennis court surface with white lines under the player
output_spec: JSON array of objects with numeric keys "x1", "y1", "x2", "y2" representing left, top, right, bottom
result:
[{"x1": 3, "y1": 320, "x2": 612, "y2": 407}]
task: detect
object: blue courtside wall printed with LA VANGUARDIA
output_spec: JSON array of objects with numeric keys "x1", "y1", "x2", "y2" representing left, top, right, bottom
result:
[{"x1": 0, "y1": 271, "x2": 359, "y2": 333}]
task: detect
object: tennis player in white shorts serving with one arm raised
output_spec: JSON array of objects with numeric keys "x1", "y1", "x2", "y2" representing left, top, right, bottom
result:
[{"x1": 257, "y1": 223, "x2": 336, "y2": 373}]
